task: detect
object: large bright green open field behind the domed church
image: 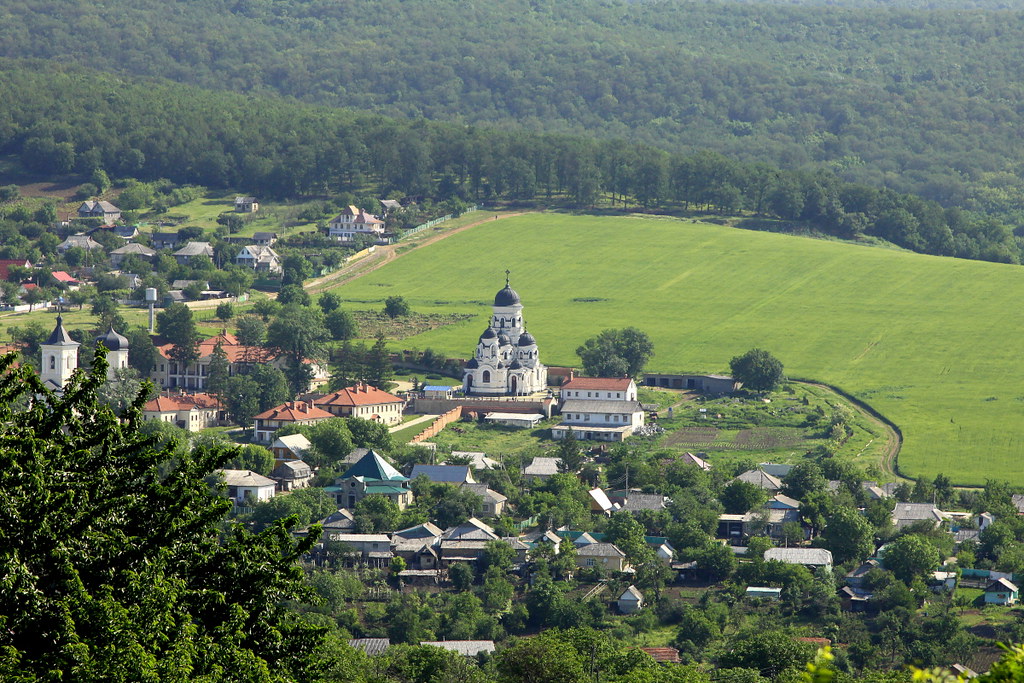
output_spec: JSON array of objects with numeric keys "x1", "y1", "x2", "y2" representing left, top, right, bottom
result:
[{"x1": 329, "y1": 214, "x2": 1024, "y2": 484}]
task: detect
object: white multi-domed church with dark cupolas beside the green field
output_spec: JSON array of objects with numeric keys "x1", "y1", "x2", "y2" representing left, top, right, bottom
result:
[{"x1": 462, "y1": 271, "x2": 548, "y2": 396}]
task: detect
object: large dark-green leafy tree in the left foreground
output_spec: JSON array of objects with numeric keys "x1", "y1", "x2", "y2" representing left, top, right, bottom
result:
[{"x1": 0, "y1": 351, "x2": 329, "y2": 681}]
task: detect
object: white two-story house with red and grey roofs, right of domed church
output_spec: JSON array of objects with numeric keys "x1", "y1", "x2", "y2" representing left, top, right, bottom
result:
[{"x1": 551, "y1": 377, "x2": 644, "y2": 441}]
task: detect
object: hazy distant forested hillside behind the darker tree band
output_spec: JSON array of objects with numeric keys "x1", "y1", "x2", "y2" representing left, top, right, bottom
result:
[{"x1": 6, "y1": 0, "x2": 1024, "y2": 223}]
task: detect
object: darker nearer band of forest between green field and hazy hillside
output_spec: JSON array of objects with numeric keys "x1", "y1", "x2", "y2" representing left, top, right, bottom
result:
[{"x1": 0, "y1": 62, "x2": 1021, "y2": 263}]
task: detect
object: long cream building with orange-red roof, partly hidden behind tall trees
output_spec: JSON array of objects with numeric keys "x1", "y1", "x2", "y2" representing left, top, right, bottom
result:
[{"x1": 151, "y1": 332, "x2": 330, "y2": 391}]
